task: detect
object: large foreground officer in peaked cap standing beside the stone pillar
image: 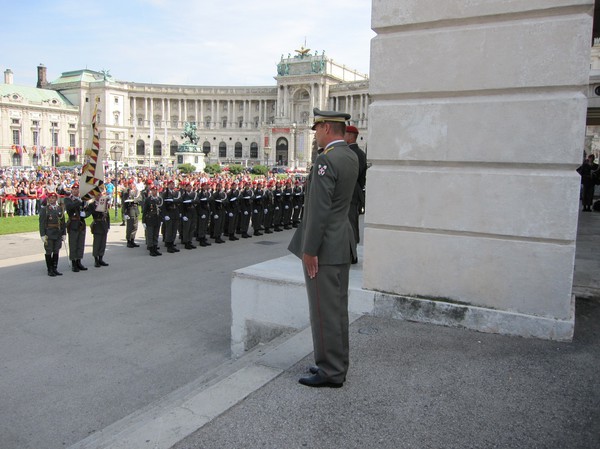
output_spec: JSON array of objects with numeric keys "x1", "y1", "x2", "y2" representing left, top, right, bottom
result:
[{"x1": 288, "y1": 108, "x2": 358, "y2": 388}]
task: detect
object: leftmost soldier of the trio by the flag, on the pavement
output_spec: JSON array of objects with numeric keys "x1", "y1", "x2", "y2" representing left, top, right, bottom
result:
[{"x1": 39, "y1": 192, "x2": 67, "y2": 277}]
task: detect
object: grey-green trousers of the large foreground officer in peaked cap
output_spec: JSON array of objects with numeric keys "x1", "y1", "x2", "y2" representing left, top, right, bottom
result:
[{"x1": 304, "y1": 264, "x2": 350, "y2": 383}]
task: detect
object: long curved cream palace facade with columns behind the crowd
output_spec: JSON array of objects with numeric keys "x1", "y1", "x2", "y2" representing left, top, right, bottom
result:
[{"x1": 0, "y1": 48, "x2": 369, "y2": 170}]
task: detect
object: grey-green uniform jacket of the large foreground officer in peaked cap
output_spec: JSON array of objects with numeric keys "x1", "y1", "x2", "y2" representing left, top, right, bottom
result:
[{"x1": 288, "y1": 141, "x2": 358, "y2": 265}]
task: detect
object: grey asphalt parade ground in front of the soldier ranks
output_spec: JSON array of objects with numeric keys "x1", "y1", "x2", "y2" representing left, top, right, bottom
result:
[{"x1": 0, "y1": 226, "x2": 293, "y2": 449}]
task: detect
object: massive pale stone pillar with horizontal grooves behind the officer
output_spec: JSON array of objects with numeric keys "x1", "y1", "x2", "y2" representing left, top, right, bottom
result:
[{"x1": 363, "y1": 0, "x2": 594, "y2": 340}]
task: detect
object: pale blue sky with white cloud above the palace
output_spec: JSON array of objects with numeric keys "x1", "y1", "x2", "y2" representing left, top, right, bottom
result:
[{"x1": 0, "y1": 0, "x2": 375, "y2": 86}]
